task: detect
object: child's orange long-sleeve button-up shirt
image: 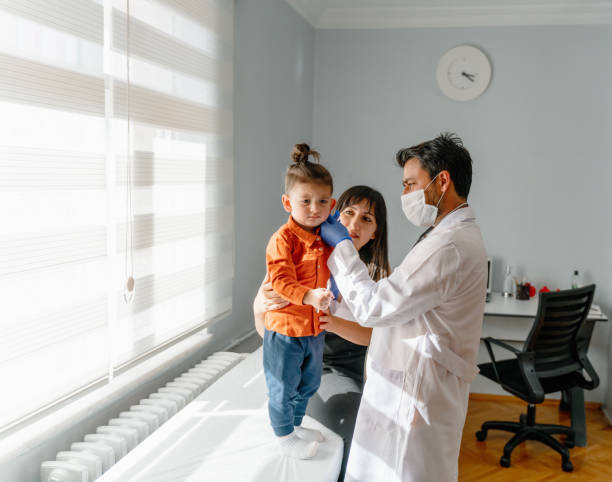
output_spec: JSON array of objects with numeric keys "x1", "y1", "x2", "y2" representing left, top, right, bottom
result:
[{"x1": 265, "y1": 216, "x2": 333, "y2": 337}]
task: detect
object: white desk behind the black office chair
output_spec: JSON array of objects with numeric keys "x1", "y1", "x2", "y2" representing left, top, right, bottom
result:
[{"x1": 471, "y1": 293, "x2": 610, "y2": 445}]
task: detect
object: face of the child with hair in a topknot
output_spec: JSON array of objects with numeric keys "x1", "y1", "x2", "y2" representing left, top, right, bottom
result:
[{"x1": 283, "y1": 182, "x2": 336, "y2": 231}]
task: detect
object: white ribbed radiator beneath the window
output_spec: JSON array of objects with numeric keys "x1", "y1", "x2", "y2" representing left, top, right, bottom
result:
[{"x1": 40, "y1": 352, "x2": 245, "y2": 482}]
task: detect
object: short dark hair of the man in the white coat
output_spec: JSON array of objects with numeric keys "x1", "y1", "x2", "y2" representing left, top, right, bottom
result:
[{"x1": 395, "y1": 132, "x2": 472, "y2": 199}]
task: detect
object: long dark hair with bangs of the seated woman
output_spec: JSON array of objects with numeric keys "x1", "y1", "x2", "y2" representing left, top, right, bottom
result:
[{"x1": 336, "y1": 186, "x2": 391, "y2": 281}]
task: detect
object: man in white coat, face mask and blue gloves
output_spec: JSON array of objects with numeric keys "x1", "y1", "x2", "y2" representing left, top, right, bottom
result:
[{"x1": 321, "y1": 134, "x2": 487, "y2": 482}]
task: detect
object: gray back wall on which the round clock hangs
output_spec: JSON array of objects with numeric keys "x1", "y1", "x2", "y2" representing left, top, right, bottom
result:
[{"x1": 314, "y1": 26, "x2": 612, "y2": 410}]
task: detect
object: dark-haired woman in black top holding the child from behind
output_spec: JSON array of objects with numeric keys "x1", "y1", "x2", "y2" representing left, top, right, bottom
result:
[{"x1": 253, "y1": 186, "x2": 391, "y2": 480}]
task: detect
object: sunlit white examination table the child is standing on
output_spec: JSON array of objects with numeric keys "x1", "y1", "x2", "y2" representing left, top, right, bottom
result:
[{"x1": 98, "y1": 348, "x2": 343, "y2": 482}]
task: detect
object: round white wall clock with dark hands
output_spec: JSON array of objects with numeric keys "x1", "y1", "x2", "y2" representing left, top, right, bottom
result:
[{"x1": 436, "y1": 45, "x2": 491, "y2": 101}]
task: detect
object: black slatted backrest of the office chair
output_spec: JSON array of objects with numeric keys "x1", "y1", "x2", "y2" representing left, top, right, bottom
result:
[{"x1": 524, "y1": 284, "x2": 595, "y2": 377}]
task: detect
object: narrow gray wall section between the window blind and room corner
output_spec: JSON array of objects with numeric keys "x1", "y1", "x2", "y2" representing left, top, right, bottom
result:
[{"x1": 214, "y1": 0, "x2": 315, "y2": 346}]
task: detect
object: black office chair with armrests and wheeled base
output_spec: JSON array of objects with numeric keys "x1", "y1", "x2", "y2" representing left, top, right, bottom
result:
[{"x1": 476, "y1": 285, "x2": 599, "y2": 472}]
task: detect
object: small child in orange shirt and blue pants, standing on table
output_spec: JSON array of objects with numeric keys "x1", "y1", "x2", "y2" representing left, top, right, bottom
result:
[{"x1": 263, "y1": 144, "x2": 336, "y2": 459}]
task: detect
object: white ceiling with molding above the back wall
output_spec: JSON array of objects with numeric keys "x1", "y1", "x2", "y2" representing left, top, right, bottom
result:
[{"x1": 287, "y1": 0, "x2": 612, "y2": 28}]
